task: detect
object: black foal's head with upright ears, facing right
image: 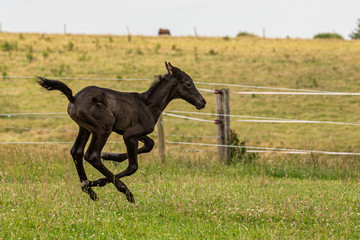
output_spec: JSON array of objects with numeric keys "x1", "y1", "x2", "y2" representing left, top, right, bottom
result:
[{"x1": 165, "y1": 62, "x2": 206, "y2": 109}]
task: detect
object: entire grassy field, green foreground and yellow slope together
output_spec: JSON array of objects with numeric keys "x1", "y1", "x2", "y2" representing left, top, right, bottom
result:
[{"x1": 0, "y1": 33, "x2": 360, "y2": 239}]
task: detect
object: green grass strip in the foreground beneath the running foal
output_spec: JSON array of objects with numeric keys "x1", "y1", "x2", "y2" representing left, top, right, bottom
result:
[{"x1": 0, "y1": 146, "x2": 360, "y2": 239}]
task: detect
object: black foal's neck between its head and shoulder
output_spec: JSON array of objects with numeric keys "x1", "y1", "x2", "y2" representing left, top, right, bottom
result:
[{"x1": 146, "y1": 79, "x2": 175, "y2": 121}]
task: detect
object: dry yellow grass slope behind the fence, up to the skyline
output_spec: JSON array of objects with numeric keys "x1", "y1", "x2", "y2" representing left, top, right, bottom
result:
[{"x1": 0, "y1": 33, "x2": 360, "y2": 151}]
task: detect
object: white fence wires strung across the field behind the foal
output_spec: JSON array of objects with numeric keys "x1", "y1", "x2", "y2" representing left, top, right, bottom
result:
[{"x1": 0, "y1": 76, "x2": 360, "y2": 156}]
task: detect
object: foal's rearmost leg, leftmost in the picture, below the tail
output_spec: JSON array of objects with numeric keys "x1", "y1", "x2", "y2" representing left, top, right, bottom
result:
[{"x1": 70, "y1": 127, "x2": 98, "y2": 201}]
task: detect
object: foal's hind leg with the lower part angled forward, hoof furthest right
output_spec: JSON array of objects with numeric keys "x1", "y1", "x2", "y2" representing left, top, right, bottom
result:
[{"x1": 85, "y1": 131, "x2": 135, "y2": 203}]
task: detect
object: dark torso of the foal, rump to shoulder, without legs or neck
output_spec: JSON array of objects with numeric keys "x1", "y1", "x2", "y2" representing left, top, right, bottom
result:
[{"x1": 68, "y1": 86, "x2": 146, "y2": 132}]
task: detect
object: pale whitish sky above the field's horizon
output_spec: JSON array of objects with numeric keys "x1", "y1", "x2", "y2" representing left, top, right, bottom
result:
[{"x1": 0, "y1": 0, "x2": 360, "y2": 39}]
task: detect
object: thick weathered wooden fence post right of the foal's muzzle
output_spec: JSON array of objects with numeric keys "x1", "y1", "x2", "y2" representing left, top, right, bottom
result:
[{"x1": 216, "y1": 88, "x2": 231, "y2": 163}]
